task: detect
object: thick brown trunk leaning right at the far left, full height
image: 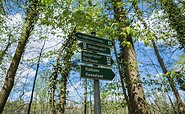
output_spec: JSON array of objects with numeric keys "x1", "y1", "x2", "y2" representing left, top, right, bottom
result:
[{"x1": 0, "y1": 0, "x2": 38, "y2": 114}]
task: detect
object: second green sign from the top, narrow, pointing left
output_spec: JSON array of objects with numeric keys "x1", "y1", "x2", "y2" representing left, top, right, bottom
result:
[{"x1": 78, "y1": 42, "x2": 110, "y2": 54}]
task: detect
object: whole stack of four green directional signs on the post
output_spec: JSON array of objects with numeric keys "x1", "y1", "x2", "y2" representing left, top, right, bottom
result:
[{"x1": 75, "y1": 33, "x2": 115, "y2": 80}]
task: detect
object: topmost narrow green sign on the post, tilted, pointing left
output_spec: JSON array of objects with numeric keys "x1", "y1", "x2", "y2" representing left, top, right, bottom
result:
[{"x1": 75, "y1": 32, "x2": 113, "y2": 47}]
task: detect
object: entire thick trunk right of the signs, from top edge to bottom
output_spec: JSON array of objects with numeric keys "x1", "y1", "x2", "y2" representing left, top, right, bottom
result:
[{"x1": 112, "y1": 0, "x2": 148, "y2": 114}]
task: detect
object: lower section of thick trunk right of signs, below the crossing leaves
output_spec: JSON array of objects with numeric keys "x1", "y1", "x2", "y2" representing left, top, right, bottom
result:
[{"x1": 122, "y1": 37, "x2": 148, "y2": 114}]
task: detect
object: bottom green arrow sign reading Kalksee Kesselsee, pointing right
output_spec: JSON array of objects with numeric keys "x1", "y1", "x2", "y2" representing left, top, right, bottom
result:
[{"x1": 80, "y1": 65, "x2": 115, "y2": 80}]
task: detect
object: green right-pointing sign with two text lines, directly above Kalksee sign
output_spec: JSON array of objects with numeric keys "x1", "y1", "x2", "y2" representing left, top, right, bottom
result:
[{"x1": 81, "y1": 51, "x2": 114, "y2": 66}]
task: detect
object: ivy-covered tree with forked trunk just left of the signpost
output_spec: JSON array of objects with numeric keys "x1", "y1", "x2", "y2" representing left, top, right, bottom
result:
[{"x1": 50, "y1": 27, "x2": 76, "y2": 114}]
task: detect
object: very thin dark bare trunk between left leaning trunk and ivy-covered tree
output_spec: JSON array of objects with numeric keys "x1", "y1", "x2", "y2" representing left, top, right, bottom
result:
[{"x1": 27, "y1": 41, "x2": 45, "y2": 114}]
